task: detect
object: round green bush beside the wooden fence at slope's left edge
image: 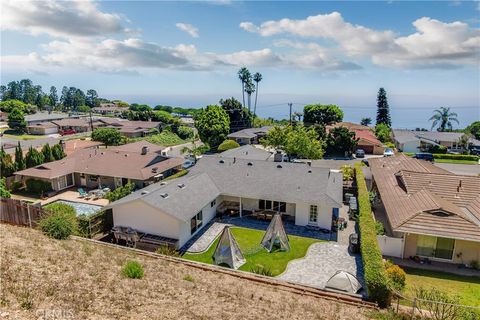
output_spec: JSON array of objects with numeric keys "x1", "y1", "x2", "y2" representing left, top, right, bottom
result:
[{"x1": 39, "y1": 203, "x2": 78, "y2": 240}]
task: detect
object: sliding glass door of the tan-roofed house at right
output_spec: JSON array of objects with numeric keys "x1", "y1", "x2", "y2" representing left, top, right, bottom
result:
[{"x1": 417, "y1": 235, "x2": 455, "y2": 260}]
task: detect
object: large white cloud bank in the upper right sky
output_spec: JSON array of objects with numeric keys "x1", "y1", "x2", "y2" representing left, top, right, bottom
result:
[{"x1": 240, "y1": 12, "x2": 480, "y2": 68}]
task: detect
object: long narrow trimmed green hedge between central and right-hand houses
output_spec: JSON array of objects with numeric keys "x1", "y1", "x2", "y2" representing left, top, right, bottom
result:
[{"x1": 355, "y1": 163, "x2": 392, "y2": 308}]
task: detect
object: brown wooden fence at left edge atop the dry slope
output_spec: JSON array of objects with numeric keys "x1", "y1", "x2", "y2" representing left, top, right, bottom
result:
[{"x1": 0, "y1": 198, "x2": 47, "y2": 228}]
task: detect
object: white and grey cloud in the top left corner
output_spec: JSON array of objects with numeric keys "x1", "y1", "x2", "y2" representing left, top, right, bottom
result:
[{"x1": 1, "y1": 0, "x2": 131, "y2": 38}]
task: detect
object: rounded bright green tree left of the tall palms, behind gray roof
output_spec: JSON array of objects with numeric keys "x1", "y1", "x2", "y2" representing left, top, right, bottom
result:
[{"x1": 195, "y1": 105, "x2": 230, "y2": 150}]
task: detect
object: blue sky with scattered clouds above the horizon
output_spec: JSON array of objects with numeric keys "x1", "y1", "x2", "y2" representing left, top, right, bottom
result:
[{"x1": 0, "y1": 0, "x2": 480, "y2": 128}]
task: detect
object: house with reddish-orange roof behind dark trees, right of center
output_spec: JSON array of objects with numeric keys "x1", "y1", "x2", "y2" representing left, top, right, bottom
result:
[{"x1": 326, "y1": 122, "x2": 385, "y2": 155}]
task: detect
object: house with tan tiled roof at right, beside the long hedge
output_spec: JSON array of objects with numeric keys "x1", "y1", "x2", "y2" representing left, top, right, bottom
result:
[{"x1": 369, "y1": 154, "x2": 480, "y2": 264}]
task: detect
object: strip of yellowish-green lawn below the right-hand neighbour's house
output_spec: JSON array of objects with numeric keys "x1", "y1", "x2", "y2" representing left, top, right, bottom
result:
[{"x1": 404, "y1": 268, "x2": 480, "y2": 306}]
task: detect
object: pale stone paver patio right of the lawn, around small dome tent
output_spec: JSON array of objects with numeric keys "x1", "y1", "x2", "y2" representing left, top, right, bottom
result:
[{"x1": 277, "y1": 242, "x2": 363, "y2": 289}]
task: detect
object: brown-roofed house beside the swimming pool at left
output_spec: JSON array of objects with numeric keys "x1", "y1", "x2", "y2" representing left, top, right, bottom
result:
[{"x1": 15, "y1": 141, "x2": 183, "y2": 191}]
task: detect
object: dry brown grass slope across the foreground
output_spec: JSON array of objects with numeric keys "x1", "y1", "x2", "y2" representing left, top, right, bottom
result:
[{"x1": 0, "y1": 224, "x2": 368, "y2": 320}]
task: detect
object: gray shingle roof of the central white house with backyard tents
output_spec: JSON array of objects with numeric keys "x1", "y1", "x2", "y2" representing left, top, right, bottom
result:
[{"x1": 106, "y1": 156, "x2": 343, "y2": 221}]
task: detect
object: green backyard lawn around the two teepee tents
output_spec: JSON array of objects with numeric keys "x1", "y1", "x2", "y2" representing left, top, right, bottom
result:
[{"x1": 183, "y1": 227, "x2": 319, "y2": 276}]
